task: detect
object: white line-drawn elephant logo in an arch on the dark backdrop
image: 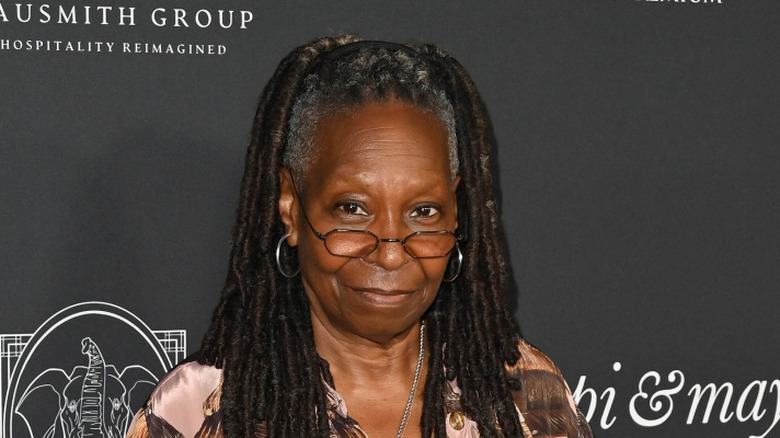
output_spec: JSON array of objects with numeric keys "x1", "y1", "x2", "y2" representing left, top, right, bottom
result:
[{"x1": 0, "y1": 301, "x2": 187, "y2": 438}]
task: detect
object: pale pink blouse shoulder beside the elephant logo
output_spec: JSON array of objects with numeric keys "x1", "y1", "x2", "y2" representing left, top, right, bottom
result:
[{"x1": 128, "y1": 362, "x2": 222, "y2": 437}]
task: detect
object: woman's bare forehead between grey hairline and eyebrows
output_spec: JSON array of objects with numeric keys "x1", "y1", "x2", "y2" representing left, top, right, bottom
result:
[{"x1": 304, "y1": 101, "x2": 450, "y2": 185}]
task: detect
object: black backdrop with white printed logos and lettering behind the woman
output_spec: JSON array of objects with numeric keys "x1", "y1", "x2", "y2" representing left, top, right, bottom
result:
[{"x1": 0, "y1": 0, "x2": 780, "y2": 438}]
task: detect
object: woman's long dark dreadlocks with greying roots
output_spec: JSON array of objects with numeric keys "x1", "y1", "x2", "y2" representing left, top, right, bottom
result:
[{"x1": 195, "y1": 35, "x2": 556, "y2": 438}]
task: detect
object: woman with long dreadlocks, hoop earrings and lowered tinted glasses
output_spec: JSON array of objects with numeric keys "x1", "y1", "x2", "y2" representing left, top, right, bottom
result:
[{"x1": 129, "y1": 36, "x2": 591, "y2": 438}]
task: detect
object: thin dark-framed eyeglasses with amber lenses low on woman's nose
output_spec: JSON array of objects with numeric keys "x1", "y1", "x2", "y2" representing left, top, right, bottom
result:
[{"x1": 293, "y1": 182, "x2": 460, "y2": 259}]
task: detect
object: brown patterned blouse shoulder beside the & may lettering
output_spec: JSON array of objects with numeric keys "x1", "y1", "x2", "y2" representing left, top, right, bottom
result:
[{"x1": 506, "y1": 339, "x2": 591, "y2": 437}]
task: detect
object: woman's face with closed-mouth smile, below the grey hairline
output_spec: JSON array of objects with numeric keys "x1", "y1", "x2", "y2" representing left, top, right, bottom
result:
[{"x1": 279, "y1": 101, "x2": 457, "y2": 342}]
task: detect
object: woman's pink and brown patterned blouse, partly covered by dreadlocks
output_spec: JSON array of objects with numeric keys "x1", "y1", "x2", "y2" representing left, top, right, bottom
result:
[{"x1": 127, "y1": 340, "x2": 593, "y2": 438}]
